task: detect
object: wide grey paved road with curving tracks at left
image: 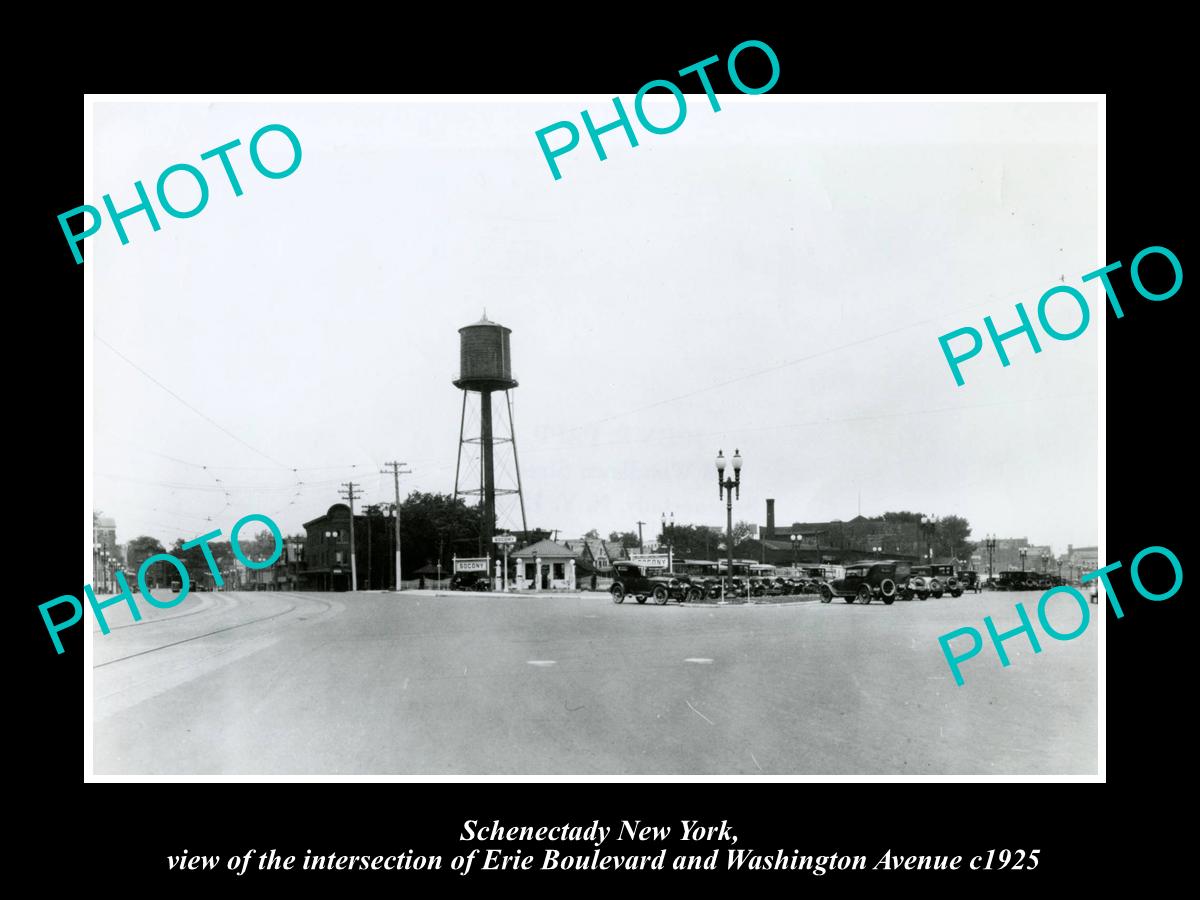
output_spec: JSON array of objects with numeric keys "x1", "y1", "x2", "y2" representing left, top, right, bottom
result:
[{"x1": 92, "y1": 592, "x2": 1103, "y2": 776}]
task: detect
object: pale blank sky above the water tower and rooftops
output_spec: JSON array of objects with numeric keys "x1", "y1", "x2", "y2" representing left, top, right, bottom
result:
[{"x1": 85, "y1": 95, "x2": 1110, "y2": 551}]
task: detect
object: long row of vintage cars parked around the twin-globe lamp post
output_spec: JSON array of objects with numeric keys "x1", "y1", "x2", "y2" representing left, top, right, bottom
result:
[{"x1": 611, "y1": 559, "x2": 980, "y2": 604}]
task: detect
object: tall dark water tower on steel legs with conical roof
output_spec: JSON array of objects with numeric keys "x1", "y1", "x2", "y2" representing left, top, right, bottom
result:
[{"x1": 454, "y1": 311, "x2": 528, "y2": 552}]
